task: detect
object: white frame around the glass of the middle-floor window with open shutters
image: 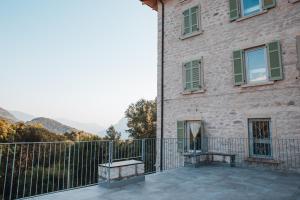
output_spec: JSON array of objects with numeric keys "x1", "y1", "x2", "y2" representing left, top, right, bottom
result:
[{"x1": 244, "y1": 46, "x2": 270, "y2": 84}]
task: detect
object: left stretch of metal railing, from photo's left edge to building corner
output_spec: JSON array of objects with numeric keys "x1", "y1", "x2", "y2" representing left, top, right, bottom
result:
[{"x1": 0, "y1": 139, "x2": 156, "y2": 200}]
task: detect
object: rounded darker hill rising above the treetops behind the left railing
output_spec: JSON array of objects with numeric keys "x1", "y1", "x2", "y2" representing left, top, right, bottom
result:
[{"x1": 26, "y1": 117, "x2": 78, "y2": 134}]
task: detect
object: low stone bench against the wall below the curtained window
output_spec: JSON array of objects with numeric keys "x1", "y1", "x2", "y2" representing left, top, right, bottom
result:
[{"x1": 184, "y1": 152, "x2": 235, "y2": 167}]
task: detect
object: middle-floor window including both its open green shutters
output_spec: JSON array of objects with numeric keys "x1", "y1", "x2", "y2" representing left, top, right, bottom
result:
[{"x1": 233, "y1": 41, "x2": 283, "y2": 85}]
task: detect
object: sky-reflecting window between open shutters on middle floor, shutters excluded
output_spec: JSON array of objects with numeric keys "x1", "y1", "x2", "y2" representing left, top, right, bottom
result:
[{"x1": 245, "y1": 47, "x2": 268, "y2": 83}]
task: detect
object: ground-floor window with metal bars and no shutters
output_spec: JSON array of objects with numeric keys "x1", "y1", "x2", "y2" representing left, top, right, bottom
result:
[{"x1": 248, "y1": 119, "x2": 272, "y2": 158}]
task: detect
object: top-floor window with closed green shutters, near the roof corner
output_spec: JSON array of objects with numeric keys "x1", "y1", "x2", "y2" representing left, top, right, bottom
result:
[{"x1": 182, "y1": 6, "x2": 200, "y2": 35}]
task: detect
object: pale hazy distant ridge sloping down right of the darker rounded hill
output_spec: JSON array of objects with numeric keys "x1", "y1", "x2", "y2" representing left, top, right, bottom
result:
[{"x1": 56, "y1": 119, "x2": 104, "y2": 134}]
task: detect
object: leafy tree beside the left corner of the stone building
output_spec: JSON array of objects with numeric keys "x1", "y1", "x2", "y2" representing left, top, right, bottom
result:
[{"x1": 125, "y1": 99, "x2": 157, "y2": 139}]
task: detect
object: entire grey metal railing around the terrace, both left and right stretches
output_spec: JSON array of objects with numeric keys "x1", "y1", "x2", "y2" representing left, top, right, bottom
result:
[{"x1": 0, "y1": 137, "x2": 300, "y2": 200}]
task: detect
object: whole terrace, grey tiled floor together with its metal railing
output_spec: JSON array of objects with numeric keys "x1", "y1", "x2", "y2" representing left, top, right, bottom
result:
[{"x1": 0, "y1": 138, "x2": 300, "y2": 200}]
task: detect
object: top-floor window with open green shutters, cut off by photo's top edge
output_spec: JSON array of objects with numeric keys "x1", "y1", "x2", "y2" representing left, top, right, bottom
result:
[{"x1": 229, "y1": 0, "x2": 276, "y2": 21}]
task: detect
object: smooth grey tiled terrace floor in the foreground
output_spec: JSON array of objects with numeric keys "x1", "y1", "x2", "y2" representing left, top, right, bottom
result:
[{"x1": 36, "y1": 166, "x2": 300, "y2": 200}]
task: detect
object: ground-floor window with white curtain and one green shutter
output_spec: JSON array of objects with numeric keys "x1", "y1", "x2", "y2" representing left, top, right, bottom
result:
[{"x1": 177, "y1": 120, "x2": 204, "y2": 152}]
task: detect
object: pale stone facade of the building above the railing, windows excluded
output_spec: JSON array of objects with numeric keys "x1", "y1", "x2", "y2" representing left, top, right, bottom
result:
[{"x1": 157, "y1": 0, "x2": 300, "y2": 142}]
